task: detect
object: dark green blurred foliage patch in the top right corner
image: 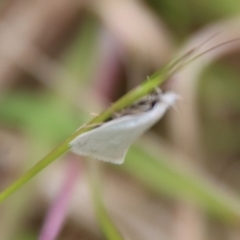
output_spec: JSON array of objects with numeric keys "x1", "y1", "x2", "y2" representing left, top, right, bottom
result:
[{"x1": 147, "y1": 0, "x2": 240, "y2": 39}]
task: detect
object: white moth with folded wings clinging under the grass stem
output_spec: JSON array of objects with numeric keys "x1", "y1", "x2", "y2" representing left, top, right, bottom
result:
[{"x1": 70, "y1": 89, "x2": 178, "y2": 164}]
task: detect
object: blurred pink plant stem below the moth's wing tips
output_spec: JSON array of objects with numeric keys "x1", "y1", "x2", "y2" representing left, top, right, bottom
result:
[{"x1": 38, "y1": 157, "x2": 79, "y2": 240}]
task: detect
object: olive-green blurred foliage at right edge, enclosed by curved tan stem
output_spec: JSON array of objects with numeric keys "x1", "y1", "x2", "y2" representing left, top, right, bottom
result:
[{"x1": 199, "y1": 63, "x2": 240, "y2": 154}]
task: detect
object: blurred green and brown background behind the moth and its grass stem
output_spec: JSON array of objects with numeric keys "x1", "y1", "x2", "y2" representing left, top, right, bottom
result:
[{"x1": 0, "y1": 0, "x2": 240, "y2": 240}]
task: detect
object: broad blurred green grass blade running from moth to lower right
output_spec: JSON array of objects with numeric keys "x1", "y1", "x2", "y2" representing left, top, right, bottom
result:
[{"x1": 121, "y1": 142, "x2": 240, "y2": 223}]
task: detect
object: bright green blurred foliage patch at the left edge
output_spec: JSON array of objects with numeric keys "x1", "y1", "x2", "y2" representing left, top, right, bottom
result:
[{"x1": 0, "y1": 91, "x2": 80, "y2": 144}]
